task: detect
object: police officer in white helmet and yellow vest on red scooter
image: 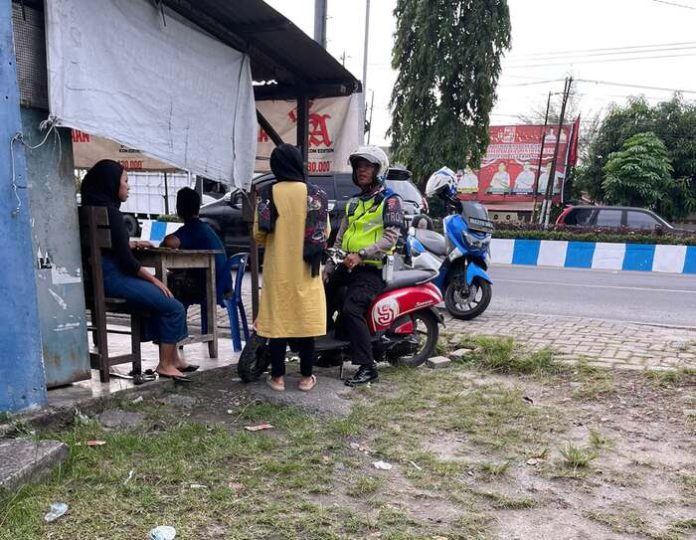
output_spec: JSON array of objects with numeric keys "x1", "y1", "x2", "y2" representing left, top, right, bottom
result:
[{"x1": 326, "y1": 146, "x2": 404, "y2": 386}]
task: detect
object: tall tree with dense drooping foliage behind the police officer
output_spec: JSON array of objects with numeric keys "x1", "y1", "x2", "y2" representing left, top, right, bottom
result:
[{"x1": 389, "y1": 0, "x2": 510, "y2": 181}]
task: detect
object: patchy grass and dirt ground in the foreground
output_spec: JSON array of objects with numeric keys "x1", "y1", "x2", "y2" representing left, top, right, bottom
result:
[{"x1": 0, "y1": 343, "x2": 696, "y2": 540}]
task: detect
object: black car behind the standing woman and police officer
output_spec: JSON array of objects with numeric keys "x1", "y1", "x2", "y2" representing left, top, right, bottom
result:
[{"x1": 200, "y1": 168, "x2": 427, "y2": 256}]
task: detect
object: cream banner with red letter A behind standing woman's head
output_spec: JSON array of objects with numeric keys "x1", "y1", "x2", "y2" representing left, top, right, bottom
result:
[{"x1": 255, "y1": 94, "x2": 363, "y2": 174}]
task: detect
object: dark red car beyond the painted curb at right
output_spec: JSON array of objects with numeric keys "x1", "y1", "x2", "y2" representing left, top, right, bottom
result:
[{"x1": 556, "y1": 206, "x2": 674, "y2": 231}]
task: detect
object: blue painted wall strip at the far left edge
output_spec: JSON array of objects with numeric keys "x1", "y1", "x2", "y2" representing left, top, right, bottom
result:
[{"x1": 0, "y1": 0, "x2": 46, "y2": 411}]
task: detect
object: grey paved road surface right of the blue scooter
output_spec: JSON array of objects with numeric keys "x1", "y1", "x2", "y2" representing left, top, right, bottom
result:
[{"x1": 489, "y1": 266, "x2": 696, "y2": 328}]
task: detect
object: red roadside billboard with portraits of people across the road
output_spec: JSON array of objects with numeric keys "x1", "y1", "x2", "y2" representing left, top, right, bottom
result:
[{"x1": 456, "y1": 119, "x2": 579, "y2": 203}]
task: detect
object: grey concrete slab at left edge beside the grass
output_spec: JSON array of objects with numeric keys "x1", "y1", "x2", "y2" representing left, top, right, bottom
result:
[{"x1": 0, "y1": 439, "x2": 68, "y2": 489}]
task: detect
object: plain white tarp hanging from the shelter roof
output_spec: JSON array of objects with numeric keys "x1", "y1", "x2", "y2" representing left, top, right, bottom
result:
[{"x1": 46, "y1": 0, "x2": 257, "y2": 188}]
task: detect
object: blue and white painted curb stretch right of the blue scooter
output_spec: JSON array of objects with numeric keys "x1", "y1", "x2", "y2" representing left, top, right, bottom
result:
[{"x1": 491, "y1": 238, "x2": 696, "y2": 274}]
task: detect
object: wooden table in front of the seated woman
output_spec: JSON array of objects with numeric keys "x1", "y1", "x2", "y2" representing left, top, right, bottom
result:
[{"x1": 133, "y1": 248, "x2": 221, "y2": 358}]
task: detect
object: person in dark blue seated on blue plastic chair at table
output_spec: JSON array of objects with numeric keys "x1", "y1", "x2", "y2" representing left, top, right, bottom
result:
[{"x1": 162, "y1": 188, "x2": 232, "y2": 306}]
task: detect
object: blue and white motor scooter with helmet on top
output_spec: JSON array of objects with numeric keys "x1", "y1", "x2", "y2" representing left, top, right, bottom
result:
[{"x1": 406, "y1": 170, "x2": 493, "y2": 320}]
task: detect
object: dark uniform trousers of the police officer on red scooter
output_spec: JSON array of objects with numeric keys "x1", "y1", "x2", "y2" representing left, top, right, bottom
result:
[{"x1": 326, "y1": 265, "x2": 384, "y2": 365}]
